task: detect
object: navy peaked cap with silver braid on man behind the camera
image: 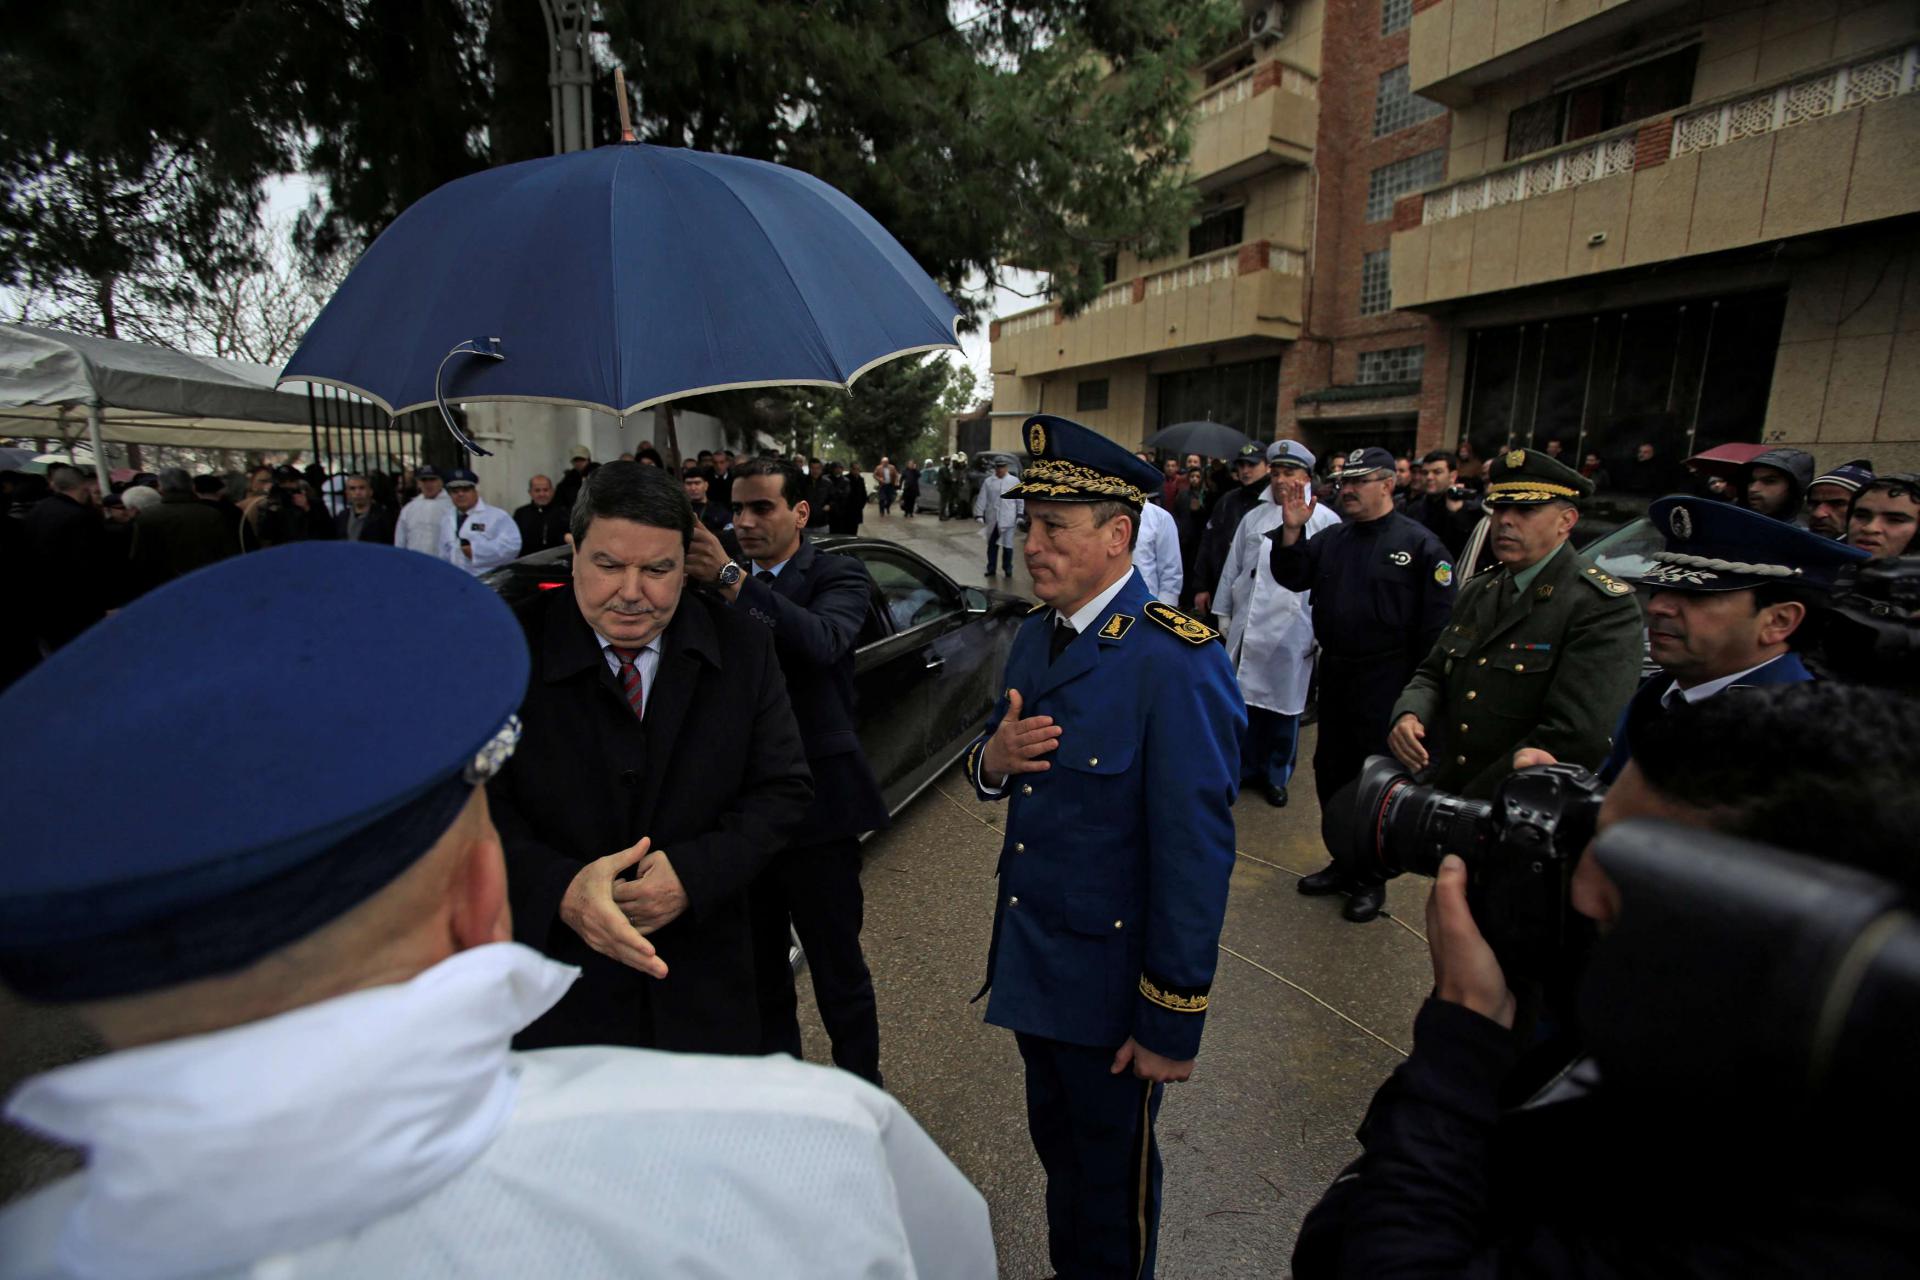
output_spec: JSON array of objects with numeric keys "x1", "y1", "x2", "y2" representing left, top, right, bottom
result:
[{"x1": 1632, "y1": 497, "x2": 1872, "y2": 591}]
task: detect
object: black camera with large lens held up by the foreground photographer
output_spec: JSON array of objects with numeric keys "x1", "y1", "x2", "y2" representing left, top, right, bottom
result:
[{"x1": 1334, "y1": 756, "x2": 1607, "y2": 977}]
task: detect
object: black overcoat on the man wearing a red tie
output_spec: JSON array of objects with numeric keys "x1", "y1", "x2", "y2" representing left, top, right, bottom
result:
[{"x1": 488, "y1": 591, "x2": 812, "y2": 1054}]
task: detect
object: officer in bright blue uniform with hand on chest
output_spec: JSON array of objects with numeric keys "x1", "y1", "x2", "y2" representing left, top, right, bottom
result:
[{"x1": 966, "y1": 416, "x2": 1246, "y2": 1276}]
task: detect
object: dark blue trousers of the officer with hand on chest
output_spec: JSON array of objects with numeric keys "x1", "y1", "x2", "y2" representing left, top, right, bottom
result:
[{"x1": 1014, "y1": 1032, "x2": 1165, "y2": 1280}]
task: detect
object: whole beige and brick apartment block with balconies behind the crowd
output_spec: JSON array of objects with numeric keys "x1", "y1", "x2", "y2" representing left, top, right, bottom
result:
[{"x1": 991, "y1": 0, "x2": 1920, "y2": 474}]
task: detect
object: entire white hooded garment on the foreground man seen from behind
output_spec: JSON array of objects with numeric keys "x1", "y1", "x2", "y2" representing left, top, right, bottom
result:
[{"x1": 0, "y1": 942, "x2": 995, "y2": 1280}]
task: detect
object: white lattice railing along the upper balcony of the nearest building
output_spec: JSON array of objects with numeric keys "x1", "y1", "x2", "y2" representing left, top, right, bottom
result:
[{"x1": 1421, "y1": 44, "x2": 1920, "y2": 226}]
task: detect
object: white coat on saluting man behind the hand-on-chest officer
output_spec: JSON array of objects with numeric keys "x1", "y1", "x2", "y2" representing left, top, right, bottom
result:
[{"x1": 1213, "y1": 486, "x2": 1340, "y2": 716}]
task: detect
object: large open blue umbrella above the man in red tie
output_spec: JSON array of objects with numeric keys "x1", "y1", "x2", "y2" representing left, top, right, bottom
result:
[{"x1": 280, "y1": 142, "x2": 960, "y2": 451}]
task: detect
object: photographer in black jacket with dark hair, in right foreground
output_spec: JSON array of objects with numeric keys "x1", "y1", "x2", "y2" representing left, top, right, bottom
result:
[{"x1": 1292, "y1": 683, "x2": 1920, "y2": 1280}]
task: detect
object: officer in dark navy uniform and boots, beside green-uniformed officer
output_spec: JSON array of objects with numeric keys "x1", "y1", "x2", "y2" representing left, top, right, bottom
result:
[{"x1": 1267, "y1": 449, "x2": 1453, "y2": 923}]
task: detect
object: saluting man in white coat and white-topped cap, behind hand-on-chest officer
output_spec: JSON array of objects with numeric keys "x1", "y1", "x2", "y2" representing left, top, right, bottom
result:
[{"x1": 1213, "y1": 439, "x2": 1340, "y2": 808}]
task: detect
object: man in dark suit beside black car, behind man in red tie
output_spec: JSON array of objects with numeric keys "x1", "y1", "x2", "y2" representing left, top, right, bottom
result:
[{"x1": 687, "y1": 461, "x2": 887, "y2": 1084}]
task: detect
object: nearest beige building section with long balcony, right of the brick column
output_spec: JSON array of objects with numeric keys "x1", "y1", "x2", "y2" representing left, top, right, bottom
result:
[{"x1": 1390, "y1": 0, "x2": 1920, "y2": 478}]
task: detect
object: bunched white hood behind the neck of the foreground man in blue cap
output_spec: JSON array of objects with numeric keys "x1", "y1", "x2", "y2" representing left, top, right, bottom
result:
[{"x1": 6, "y1": 942, "x2": 580, "y2": 1280}]
